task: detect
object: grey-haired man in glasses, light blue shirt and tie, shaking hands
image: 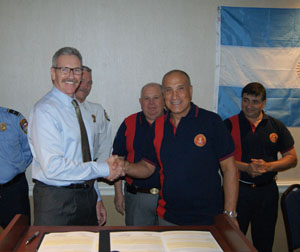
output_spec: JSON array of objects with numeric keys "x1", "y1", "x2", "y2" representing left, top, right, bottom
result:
[{"x1": 28, "y1": 47, "x2": 123, "y2": 226}]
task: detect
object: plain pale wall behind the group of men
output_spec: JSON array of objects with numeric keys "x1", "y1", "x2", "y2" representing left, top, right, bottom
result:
[{"x1": 0, "y1": 0, "x2": 300, "y2": 195}]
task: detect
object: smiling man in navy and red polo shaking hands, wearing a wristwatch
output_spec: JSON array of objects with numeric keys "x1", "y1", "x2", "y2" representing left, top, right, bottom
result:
[{"x1": 119, "y1": 70, "x2": 238, "y2": 226}]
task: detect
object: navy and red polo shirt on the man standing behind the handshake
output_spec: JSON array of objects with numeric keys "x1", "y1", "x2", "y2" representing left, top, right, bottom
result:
[{"x1": 113, "y1": 112, "x2": 160, "y2": 189}]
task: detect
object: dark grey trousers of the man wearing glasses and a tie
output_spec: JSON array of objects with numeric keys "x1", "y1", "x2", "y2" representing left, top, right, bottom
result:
[{"x1": 33, "y1": 181, "x2": 97, "y2": 226}]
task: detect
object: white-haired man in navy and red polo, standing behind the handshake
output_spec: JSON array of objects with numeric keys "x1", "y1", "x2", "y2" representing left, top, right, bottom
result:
[{"x1": 113, "y1": 83, "x2": 164, "y2": 226}]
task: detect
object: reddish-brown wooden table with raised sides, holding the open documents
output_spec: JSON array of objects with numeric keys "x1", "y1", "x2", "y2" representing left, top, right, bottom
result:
[{"x1": 0, "y1": 214, "x2": 257, "y2": 252}]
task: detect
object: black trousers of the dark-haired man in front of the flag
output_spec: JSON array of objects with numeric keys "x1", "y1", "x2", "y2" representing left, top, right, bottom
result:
[{"x1": 237, "y1": 181, "x2": 279, "y2": 252}]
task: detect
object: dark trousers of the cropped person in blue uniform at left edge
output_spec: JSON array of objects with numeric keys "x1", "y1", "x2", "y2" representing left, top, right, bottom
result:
[{"x1": 0, "y1": 174, "x2": 30, "y2": 228}]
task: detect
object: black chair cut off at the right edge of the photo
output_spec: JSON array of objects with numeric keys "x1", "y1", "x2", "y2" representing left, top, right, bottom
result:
[{"x1": 281, "y1": 184, "x2": 300, "y2": 252}]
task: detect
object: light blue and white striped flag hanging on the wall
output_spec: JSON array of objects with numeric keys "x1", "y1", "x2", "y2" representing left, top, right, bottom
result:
[{"x1": 215, "y1": 7, "x2": 300, "y2": 127}]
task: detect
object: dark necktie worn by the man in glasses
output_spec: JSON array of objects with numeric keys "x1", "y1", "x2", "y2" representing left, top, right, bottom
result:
[{"x1": 72, "y1": 100, "x2": 92, "y2": 162}]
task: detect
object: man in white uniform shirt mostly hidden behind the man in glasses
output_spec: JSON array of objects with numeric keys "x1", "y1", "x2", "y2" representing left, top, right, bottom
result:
[{"x1": 75, "y1": 66, "x2": 112, "y2": 225}]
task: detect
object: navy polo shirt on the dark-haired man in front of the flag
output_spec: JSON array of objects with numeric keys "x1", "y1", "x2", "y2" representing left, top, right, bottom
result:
[{"x1": 225, "y1": 111, "x2": 294, "y2": 184}]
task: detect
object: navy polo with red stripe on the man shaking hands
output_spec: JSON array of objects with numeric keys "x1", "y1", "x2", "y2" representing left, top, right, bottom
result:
[{"x1": 143, "y1": 103, "x2": 234, "y2": 225}]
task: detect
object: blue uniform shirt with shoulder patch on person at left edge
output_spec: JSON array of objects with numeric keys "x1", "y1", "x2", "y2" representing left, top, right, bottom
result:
[{"x1": 0, "y1": 107, "x2": 32, "y2": 184}]
